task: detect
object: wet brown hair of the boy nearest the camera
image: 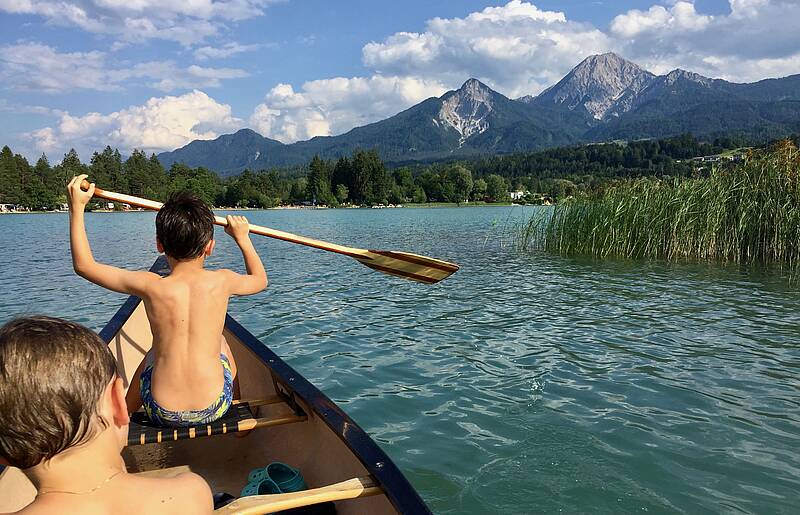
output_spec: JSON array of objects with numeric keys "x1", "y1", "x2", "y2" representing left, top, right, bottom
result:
[{"x1": 0, "y1": 316, "x2": 117, "y2": 469}]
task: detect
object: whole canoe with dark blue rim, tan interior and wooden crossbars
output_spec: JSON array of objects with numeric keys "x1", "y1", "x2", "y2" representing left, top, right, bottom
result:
[{"x1": 0, "y1": 258, "x2": 430, "y2": 515}]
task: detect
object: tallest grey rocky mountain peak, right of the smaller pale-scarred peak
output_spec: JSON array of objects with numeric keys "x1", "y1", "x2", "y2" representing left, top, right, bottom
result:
[{"x1": 537, "y1": 52, "x2": 655, "y2": 120}]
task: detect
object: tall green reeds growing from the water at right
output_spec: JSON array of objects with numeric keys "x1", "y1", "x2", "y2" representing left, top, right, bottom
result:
[{"x1": 518, "y1": 141, "x2": 800, "y2": 270}]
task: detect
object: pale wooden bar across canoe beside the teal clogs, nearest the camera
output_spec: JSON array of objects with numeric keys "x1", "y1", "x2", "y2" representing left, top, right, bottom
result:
[{"x1": 214, "y1": 476, "x2": 383, "y2": 515}]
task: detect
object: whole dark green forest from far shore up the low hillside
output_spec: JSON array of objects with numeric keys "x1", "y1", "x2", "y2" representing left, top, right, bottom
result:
[{"x1": 0, "y1": 134, "x2": 784, "y2": 210}]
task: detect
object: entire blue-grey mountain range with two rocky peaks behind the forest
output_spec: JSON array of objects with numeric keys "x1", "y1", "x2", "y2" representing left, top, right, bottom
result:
[{"x1": 158, "y1": 53, "x2": 800, "y2": 175}]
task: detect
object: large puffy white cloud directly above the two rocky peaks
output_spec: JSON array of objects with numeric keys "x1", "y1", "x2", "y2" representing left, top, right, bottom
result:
[{"x1": 362, "y1": 0, "x2": 615, "y2": 97}]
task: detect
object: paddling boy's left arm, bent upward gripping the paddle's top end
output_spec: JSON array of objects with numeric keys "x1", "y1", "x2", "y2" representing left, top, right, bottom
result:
[{"x1": 67, "y1": 175, "x2": 157, "y2": 296}]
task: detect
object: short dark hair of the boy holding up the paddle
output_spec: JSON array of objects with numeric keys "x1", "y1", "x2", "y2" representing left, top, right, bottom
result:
[{"x1": 156, "y1": 191, "x2": 214, "y2": 260}]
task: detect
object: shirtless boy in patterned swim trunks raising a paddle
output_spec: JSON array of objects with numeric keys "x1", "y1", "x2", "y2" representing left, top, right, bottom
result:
[{"x1": 67, "y1": 175, "x2": 267, "y2": 427}]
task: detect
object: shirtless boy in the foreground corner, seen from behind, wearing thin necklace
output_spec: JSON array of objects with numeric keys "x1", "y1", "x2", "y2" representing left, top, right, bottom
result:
[{"x1": 0, "y1": 317, "x2": 214, "y2": 515}]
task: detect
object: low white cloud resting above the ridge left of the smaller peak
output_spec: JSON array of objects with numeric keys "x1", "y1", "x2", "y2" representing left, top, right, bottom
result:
[{"x1": 250, "y1": 75, "x2": 446, "y2": 143}]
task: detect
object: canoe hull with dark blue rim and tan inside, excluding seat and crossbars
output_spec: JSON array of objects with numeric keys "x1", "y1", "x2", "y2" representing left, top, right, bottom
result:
[{"x1": 0, "y1": 260, "x2": 430, "y2": 515}]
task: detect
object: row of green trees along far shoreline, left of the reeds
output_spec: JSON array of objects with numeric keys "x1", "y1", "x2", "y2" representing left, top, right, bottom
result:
[{"x1": 0, "y1": 146, "x2": 509, "y2": 210}]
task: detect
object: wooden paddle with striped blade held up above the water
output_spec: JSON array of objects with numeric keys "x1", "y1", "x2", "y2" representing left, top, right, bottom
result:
[{"x1": 81, "y1": 180, "x2": 458, "y2": 284}]
